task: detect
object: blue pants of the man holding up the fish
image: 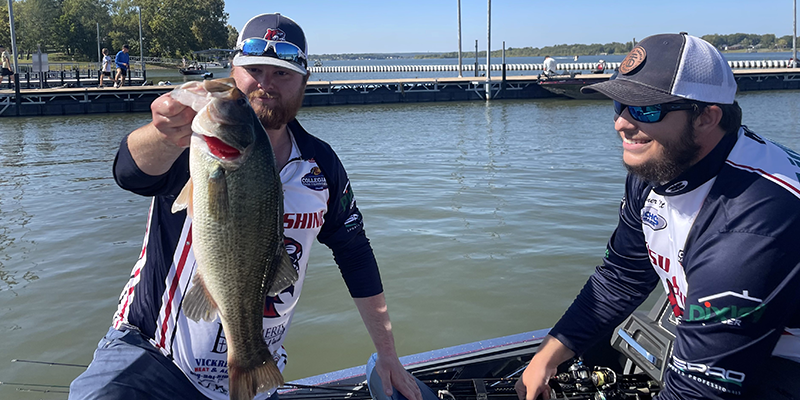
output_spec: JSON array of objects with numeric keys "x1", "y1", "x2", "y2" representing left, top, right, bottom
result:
[{"x1": 69, "y1": 328, "x2": 278, "y2": 400}]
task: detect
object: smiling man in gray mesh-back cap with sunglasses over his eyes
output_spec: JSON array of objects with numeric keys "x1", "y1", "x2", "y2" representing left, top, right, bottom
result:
[{"x1": 516, "y1": 33, "x2": 800, "y2": 400}]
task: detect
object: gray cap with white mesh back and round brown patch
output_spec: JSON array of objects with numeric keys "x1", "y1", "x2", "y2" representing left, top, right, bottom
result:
[{"x1": 581, "y1": 32, "x2": 737, "y2": 106}]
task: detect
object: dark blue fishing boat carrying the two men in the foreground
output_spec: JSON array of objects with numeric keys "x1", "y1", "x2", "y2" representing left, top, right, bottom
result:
[{"x1": 278, "y1": 296, "x2": 676, "y2": 400}]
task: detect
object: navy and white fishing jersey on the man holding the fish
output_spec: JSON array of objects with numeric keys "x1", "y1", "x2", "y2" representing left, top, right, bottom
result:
[{"x1": 108, "y1": 120, "x2": 383, "y2": 399}]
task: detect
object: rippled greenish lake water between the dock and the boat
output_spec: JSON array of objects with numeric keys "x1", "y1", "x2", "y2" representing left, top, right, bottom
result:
[{"x1": 0, "y1": 76, "x2": 800, "y2": 399}]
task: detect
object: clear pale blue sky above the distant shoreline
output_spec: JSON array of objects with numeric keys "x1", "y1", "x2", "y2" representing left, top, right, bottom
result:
[{"x1": 226, "y1": 0, "x2": 793, "y2": 54}]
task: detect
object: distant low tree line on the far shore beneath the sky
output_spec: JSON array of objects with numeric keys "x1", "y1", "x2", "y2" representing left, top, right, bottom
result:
[{"x1": 414, "y1": 33, "x2": 792, "y2": 58}]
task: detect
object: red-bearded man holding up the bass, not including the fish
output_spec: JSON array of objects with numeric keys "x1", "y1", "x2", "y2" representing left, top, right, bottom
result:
[{"x1": 70, "y1": 14, "x2": 421, "y2": 400}]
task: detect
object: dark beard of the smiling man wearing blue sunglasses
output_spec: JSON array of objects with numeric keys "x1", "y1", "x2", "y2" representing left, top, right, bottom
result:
[{"x1": 623, "y1": 119, "x2": 700, "y2": 184}]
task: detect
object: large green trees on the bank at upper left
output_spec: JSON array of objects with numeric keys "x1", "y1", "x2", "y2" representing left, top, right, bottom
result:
[{"x1": 0, "y1": 0, "x2": 239, "y2": 61}]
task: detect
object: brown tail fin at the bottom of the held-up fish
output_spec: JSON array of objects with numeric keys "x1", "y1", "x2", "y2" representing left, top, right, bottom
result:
[{"x1": 228, "y1": 349, "x2": 284, "y2": 400}]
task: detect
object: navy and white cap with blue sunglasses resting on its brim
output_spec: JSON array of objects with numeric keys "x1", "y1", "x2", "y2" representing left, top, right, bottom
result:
[{"x1": 233, "y1": 13, "x2": 308, "y2": 75}]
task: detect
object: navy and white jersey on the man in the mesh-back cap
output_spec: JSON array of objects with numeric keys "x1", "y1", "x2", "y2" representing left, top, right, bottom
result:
[{"x1": 550, "y1": 127, "x2": 800, "y2": 400}]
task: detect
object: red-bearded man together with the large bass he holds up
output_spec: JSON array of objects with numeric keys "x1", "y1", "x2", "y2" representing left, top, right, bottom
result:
[{"x1": 70, "y1": 14, "x2": 421, "y2": 400}]
